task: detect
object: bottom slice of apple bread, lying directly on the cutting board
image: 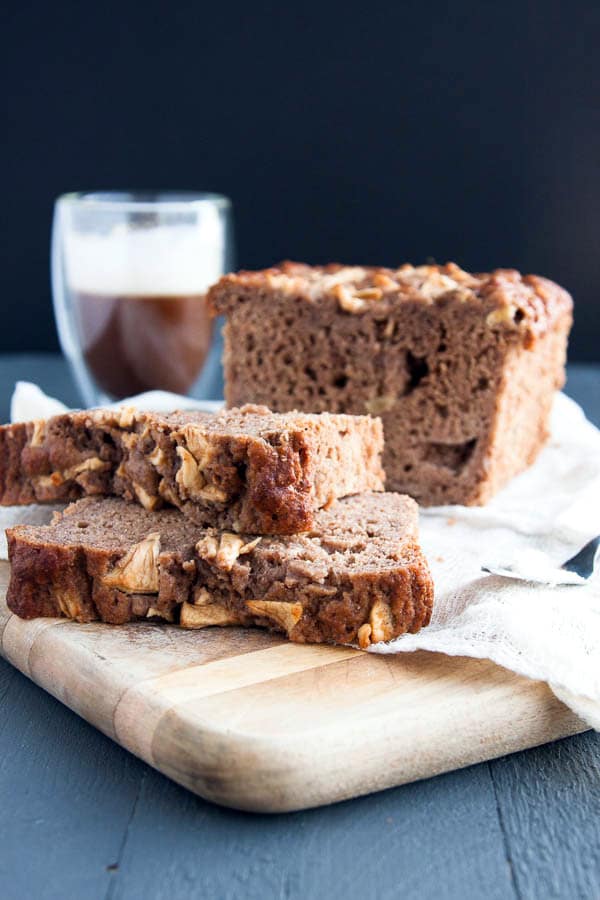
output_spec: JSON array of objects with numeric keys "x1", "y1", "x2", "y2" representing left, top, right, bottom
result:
[{"x1": 7, "y1": 492, "x2": 433, "y2": 649}]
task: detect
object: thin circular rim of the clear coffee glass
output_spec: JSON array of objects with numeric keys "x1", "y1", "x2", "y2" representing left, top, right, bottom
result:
[{"x1": 55, "y1": 190, "x2": 231, "y2": 213}]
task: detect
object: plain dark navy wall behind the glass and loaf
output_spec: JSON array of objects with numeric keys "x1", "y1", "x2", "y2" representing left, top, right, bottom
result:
[{"x1": 0, "y1": 0, "x2": 600, "y2": 359}]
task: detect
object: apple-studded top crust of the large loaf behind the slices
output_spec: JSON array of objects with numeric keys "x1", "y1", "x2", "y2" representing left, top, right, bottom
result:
[{"x1": 208, "y1": 262, "x2": 573, "y2": 345}]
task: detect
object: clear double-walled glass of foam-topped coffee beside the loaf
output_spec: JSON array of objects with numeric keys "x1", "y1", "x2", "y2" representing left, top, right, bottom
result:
[{"x1": 52, "y1": 192, "x2": 233, "y2": 406}]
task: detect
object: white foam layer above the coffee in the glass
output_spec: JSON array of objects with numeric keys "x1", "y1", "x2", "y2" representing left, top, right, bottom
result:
[{"x1": 64, "y1": 209, "x2": 225, "y2": 296}]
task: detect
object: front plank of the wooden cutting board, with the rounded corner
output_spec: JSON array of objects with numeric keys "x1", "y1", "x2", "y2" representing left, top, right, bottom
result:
[{"x1": 139, "y1": 645, "x2": 584, "y2": 813}]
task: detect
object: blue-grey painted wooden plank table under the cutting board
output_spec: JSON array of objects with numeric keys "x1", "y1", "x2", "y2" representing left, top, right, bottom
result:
[{"x1": 0, "y1": 355, "x2": 600, "y2": 900}]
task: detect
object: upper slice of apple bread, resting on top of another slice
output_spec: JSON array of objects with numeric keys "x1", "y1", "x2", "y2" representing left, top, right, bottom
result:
[{"x1": 0, "y1": 406, "x2": 384, "y2": 534}]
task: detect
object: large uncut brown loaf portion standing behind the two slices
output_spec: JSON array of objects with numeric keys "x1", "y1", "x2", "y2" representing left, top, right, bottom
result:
[{"x1": 208, "y1": 263, "x2": 572, "y2": 505}]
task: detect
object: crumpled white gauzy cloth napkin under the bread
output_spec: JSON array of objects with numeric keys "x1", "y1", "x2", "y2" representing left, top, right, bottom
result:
[{"x1": 0, "y1": 382, "x2": 600, "y2": 729}]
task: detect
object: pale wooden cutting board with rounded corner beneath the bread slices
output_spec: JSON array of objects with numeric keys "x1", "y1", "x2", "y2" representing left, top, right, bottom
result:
[{"x1": 0, "y1": 563, "x2": 587, "y2": 812}]
